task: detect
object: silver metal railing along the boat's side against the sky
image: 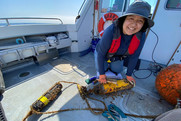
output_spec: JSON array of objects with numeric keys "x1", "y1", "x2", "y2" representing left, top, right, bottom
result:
[{"x1": 0, "y1": 17, "x2": 63, "y2": 26}]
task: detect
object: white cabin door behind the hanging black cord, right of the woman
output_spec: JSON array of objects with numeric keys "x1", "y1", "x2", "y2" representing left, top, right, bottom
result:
[{"x1": 140, "y1": 0, "x2": 181, "y2": 65}]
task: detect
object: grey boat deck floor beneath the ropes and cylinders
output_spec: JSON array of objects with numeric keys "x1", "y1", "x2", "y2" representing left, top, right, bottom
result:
[{"x1": 1, "y1": 53, "x2": 173, "y2": 121}]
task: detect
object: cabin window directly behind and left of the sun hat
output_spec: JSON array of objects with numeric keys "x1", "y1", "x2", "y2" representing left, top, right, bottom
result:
[{"x1": 101, "y1": 0, "x2": 125, "y2": 13}]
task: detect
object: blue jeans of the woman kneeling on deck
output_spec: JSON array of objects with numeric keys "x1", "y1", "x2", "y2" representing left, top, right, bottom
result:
[{"x1": 94, "y1": 50, "x2": 123, "y2": 73}]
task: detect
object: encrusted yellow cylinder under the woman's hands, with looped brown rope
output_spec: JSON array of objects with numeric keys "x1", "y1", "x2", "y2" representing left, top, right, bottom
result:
[{"x1": 77, "y1": 79, "x2": 134, "y2": 115}]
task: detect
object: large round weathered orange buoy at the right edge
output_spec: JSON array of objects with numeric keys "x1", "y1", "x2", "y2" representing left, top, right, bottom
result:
[{"x1": 155, "y1": 64, "x2": 181, "y2": 105}]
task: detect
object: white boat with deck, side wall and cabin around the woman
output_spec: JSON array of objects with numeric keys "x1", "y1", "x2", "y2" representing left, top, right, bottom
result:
[{"x1": 0, "y1": 0, "x2": 181, "y2": 121}]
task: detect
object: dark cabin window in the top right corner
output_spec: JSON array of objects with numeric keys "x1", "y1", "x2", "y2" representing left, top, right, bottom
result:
[{"x1": 166, "y1": 0, "x2": 181, "y2": 9}]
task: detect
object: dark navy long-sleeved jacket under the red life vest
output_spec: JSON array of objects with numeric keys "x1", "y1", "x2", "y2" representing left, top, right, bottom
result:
[{"x1": 96, "y1": 22, "x2": 145, "y2": 76}]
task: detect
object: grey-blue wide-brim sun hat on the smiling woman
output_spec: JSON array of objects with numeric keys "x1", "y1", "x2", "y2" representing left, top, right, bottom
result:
[{"x1": 119, "y1": 0, "x2": 154, "y2": 28}]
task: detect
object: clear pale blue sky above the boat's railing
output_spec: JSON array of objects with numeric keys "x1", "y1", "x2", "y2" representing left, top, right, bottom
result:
[{"x1": 0, "y1": 0, "x2": 156, "y2": 24}]
